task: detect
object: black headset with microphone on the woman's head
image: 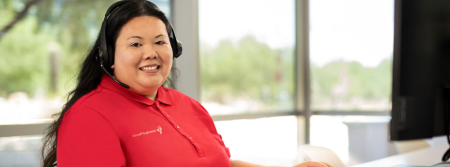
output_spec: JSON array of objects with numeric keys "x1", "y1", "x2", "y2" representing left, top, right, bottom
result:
[{"x1": 95, "y1": 0, "x2": 183, "y2": 89}]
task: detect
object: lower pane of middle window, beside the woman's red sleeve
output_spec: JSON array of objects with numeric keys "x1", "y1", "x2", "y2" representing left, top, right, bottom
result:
[{"x1": 215, "y1": 116, "x2": 304, "y2": 166}]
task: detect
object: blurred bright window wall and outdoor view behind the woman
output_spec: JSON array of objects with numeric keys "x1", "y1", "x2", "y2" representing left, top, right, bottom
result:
[{"x1": 0, "y1": 0, "x2": 442, "y2": 166}]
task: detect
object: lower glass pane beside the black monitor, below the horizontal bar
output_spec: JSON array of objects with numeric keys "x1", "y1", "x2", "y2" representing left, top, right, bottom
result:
[{"x1": 310, "y1": 116, "x2": 397, "y2": 166}]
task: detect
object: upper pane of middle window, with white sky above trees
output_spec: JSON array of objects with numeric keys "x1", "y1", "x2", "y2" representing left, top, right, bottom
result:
[{"x1": 199, "y1": 0, "x2": 295, "y2": 115}]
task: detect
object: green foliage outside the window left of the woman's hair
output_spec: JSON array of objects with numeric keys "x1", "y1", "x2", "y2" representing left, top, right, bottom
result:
[{"x1": 0, "y1": 0, "x2": 115, "y2": 97}]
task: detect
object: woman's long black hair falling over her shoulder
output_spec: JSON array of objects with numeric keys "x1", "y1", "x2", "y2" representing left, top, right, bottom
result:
[{"x1": 41, "y1": 0, "x2": 176, "y2": 167}]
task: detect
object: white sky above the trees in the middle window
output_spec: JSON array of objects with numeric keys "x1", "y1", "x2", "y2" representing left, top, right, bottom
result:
[{"x1": 199, "y1": 0, "x2": 295, "y2": 48}]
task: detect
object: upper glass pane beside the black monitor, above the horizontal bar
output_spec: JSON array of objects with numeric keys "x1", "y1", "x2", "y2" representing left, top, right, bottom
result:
[{"x1": 310, "y1": 0, "x2": 394, "y2": 111}]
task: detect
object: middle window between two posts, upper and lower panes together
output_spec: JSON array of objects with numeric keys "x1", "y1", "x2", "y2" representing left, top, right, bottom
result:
[{"x1": 200, "y1": 0, "x2": 304, "y2": 166}]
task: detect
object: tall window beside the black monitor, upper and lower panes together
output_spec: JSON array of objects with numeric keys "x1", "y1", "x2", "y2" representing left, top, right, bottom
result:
[{"x1": 309, "y1": 0, "x2": 396, "y2": 166}]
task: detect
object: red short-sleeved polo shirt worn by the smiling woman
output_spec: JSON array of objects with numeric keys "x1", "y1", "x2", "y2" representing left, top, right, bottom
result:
[{"x1": 57, "y1": 75, "x2": 231, "y2": 167}]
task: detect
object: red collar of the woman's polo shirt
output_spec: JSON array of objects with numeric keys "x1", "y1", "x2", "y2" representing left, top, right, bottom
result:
[{"x1": 100, "y1": 75, "x2": 172, "y2": 105}]
